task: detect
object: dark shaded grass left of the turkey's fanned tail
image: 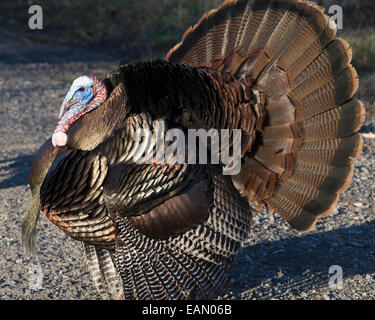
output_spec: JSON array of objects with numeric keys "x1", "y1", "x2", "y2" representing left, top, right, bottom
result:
[{"x1": 2, "y1": 0, "x2": 223, "y2": 57}]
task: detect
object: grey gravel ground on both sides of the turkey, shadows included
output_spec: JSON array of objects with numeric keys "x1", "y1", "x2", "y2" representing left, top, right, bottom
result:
[{"x1": 0, "y1": 33, "x2": 375, "y2": 300}]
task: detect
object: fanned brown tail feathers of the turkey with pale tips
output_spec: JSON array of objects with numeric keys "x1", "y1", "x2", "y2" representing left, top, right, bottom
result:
[{"x1": 166, "y1": 0, "x2": 365, "y2": 231}]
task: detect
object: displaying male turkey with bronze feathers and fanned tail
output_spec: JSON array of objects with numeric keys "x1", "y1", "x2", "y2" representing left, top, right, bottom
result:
[{"x1": 23, "y1": 0, "x2": 365, "y2": 299}]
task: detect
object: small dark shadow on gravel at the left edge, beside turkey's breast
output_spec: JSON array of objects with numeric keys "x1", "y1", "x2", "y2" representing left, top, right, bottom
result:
[{"x1": 0, "y1": 154, "x2": 34, "y2": 190}]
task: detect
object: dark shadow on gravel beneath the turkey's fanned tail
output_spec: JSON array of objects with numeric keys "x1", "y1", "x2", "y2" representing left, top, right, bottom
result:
[{"x1": 232, "y1": 221, "x2": 375, "y2": 299}]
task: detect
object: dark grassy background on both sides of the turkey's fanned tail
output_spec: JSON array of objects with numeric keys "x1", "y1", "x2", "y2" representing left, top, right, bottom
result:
[{"x1": 0, "y1": 0, "x2": 375, "y2": 117}]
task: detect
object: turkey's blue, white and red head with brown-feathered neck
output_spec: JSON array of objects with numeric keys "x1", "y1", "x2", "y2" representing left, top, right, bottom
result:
[{"x1": 52, "y1": 76, "x2": 127, "y2": 150}]
